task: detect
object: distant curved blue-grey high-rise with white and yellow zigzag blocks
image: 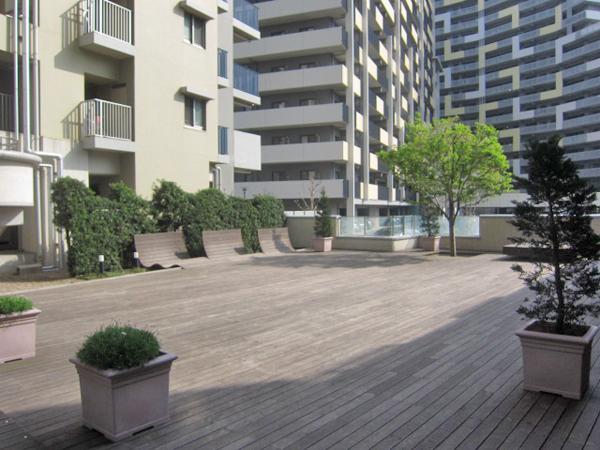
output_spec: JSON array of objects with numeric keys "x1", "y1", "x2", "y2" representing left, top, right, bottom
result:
[{"x1": 435, "y1": 0, "x2": 600, "y2": 199}]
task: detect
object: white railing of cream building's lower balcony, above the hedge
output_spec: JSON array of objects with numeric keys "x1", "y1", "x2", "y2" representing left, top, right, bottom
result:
[{"x1": 81, "y1": 99, "x2": 133, "y2": 141}]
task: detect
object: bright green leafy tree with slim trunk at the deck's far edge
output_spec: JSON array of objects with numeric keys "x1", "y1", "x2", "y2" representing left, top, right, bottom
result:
[{"x1": 378, "y1": 118, "x2": 512, "y2": 256}]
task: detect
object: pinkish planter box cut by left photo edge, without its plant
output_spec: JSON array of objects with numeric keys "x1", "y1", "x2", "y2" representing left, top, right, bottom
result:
[{"x1": 0, "y1": 308, "x2": 41, "y2": 363}]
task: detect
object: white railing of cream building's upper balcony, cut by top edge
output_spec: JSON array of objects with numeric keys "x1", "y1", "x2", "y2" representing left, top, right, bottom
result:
[{"x1": 82, "y1": 0, "x2": 133, "y2": 44}]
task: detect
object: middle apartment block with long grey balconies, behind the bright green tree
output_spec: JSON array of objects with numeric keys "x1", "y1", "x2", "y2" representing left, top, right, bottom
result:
[{"x1": 235, "y1": 0, "x2": 437, "y2": 215}]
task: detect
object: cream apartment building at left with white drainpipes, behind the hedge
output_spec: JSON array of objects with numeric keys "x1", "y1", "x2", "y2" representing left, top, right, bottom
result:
[{"x1": 0, "y1": 0, "x2": 260, "y2": 268}]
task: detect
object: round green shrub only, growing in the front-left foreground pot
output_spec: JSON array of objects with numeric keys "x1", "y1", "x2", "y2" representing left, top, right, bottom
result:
[{"x1": 77, "y1": 324, "x2": 160, "y2": 370}]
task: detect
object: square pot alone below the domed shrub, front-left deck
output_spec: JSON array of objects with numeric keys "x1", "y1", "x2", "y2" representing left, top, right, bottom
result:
[{"x1": 69, "y1": 353, "x2": 177, "y2": 441}]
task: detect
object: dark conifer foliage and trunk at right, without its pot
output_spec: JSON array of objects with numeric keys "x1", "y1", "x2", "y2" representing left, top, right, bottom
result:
[{"x1": 511, "y1": 136, "x2": 600, "y2": 334}]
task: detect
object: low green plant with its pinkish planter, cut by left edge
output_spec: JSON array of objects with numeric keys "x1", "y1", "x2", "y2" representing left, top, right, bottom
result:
[{"x1": 0, "y1": 295, "x2": 41, "y2": 363}]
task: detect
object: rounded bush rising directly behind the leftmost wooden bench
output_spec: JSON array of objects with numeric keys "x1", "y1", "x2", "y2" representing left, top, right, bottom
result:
[{"x1": 152, "y1": 180, "x2": 191, "y2": 231}]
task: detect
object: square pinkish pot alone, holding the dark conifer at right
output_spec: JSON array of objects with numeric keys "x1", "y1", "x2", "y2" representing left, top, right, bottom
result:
[{"x1": 517, "y1": 320, "x2": 598, "y2": 400}]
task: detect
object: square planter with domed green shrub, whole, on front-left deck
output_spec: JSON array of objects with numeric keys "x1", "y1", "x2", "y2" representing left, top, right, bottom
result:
[{"x1": 70, "y1": 324, "x2": 177, "y2": 441}]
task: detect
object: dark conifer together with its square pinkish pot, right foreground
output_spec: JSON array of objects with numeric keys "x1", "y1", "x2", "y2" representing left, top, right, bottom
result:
[{"x1": 512, "y1": 137, "x2": 600, "y2": 399}]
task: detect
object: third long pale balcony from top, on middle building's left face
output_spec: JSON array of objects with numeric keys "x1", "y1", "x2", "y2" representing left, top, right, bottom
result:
[{"x1": 259, "y1": 65, "x2": 348, "y2": 95}]
